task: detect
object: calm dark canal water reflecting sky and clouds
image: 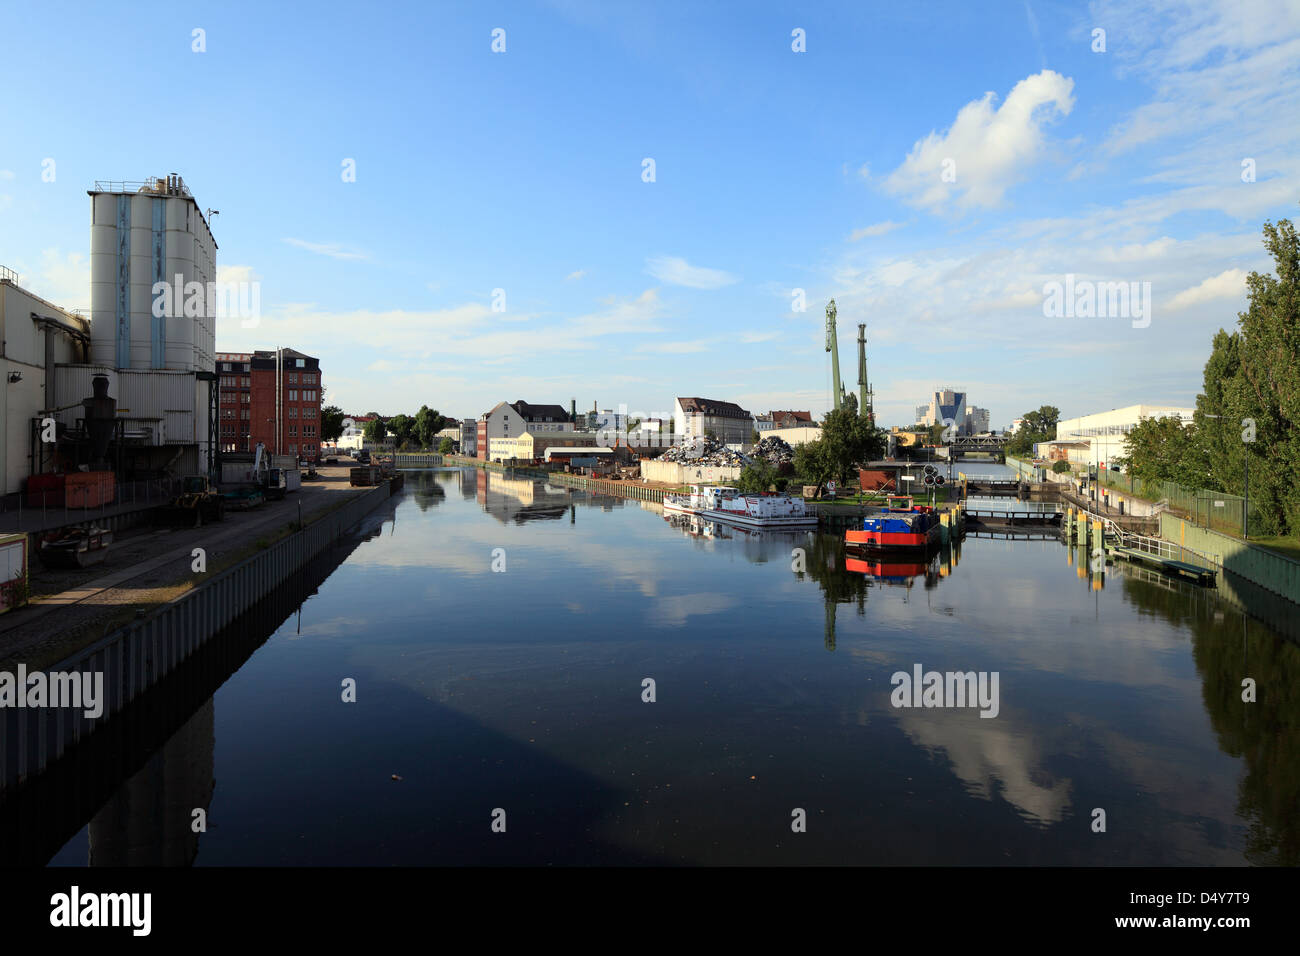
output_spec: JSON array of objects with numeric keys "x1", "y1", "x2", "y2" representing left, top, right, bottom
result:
[{"x1": 40, "y1": 466, "x2": 1300, "y2": 865}]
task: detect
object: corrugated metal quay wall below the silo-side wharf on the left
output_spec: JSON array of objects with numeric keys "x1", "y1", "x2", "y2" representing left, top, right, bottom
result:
[{"x1": 0, "y1": 481, "x2": 391, "y2": 791}]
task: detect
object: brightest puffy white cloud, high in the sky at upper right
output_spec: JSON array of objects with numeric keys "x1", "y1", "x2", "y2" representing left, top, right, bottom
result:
[{"x1": 885, "y1": 70, "x2": 1074, "y2": 212}]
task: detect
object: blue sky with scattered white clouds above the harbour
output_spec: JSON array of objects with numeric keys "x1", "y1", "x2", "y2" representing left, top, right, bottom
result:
[{"x1": 0, "y1": 0, "x2": 1300, "y2": 427}]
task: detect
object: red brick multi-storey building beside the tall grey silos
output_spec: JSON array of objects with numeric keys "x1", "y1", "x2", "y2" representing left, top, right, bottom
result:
[{"x1": 217, "y1": 349, "x2": 321, "y2": 459}]
